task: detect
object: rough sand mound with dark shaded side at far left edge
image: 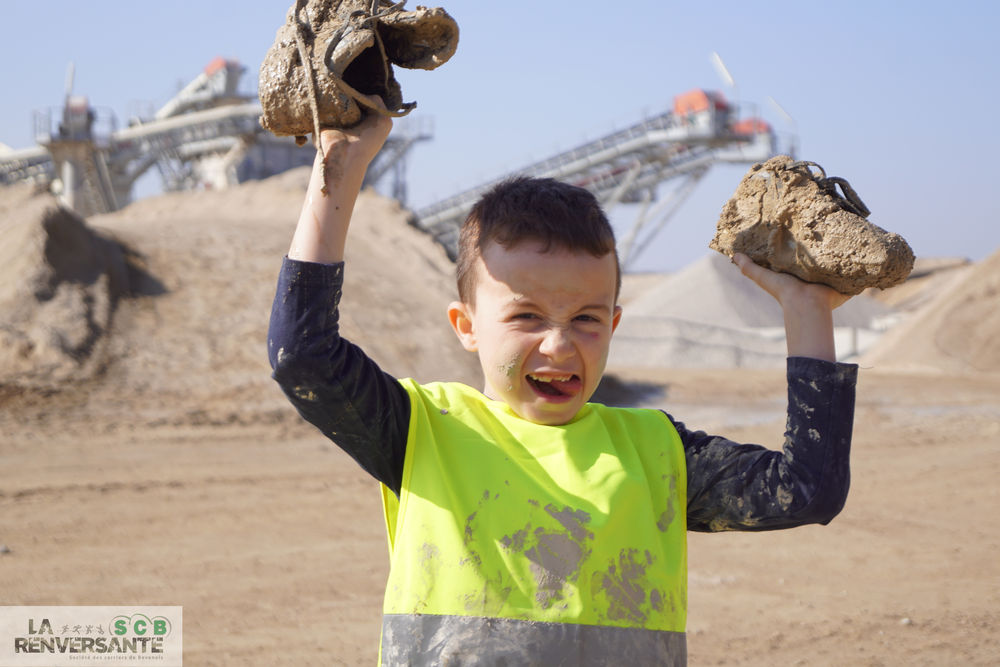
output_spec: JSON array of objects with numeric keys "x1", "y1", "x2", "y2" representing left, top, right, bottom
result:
[{"x1": 0, "y1": 187, "x2": 128, "y2": 391}]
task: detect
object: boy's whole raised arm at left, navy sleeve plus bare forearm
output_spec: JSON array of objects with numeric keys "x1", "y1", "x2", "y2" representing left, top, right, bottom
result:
[{"x1": 268, "y1": 107, "x2": 409, "y2": 493}]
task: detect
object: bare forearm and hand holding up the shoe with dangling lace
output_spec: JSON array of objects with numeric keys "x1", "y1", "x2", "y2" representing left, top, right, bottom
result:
[{"x1": 288, "y1": 109, "x2": 392, "y2": 264}]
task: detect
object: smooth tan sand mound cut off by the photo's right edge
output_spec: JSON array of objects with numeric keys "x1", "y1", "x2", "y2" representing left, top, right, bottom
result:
[{"x1": 863, "y1": 250, "x2": 1000, "y2": 373}]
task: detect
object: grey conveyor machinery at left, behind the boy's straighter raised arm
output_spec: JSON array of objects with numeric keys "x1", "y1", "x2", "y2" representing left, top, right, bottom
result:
[{"x1": 0, "y1": 58, "x2": 430, "y2": 216}]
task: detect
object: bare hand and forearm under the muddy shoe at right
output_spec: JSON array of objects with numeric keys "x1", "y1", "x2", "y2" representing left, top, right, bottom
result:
[{"x1": 733, "y1": 253, "x2": 851, "y2": 361}]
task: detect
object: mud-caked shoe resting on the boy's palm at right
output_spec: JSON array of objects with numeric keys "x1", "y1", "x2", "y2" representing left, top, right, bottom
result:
[{"x1": 709, "y1": 155, "x2": 913, "y2": 295}]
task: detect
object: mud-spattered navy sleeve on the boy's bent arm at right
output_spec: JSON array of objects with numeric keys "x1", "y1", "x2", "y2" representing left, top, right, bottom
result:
[{"x1": 671, "y1": 357, "x2": 857, "y2": 532}]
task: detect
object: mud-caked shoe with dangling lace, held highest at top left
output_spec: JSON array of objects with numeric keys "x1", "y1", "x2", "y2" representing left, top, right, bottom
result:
[{"x1": 258, "y1": 0, "x2": 458, "y2": 137}]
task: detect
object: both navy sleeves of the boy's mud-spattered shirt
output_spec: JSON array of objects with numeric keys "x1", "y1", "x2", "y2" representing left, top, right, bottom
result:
[{"x1": 268, "y1": 258, "x2": 857, "y2": 531}]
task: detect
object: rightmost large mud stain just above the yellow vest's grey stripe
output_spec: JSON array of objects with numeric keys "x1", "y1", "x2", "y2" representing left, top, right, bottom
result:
[{"x1": 591, "y1": 549, "x2": 664, "y2": 625}]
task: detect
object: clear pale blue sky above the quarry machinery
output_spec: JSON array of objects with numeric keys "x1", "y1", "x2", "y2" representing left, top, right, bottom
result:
[{"x1": 0, "y1": 0, "x2": 1000, "y2": 270}]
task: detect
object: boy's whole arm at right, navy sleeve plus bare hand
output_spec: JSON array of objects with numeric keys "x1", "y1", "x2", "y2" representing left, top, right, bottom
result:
[{"x1": 675, "y1": 254, "x2": 857, "y2": 531}]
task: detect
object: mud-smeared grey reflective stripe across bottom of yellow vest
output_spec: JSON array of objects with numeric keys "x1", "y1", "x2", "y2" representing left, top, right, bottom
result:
[{"x1": 382, "y1": 614, "x2": 687, "y2": 667}]
